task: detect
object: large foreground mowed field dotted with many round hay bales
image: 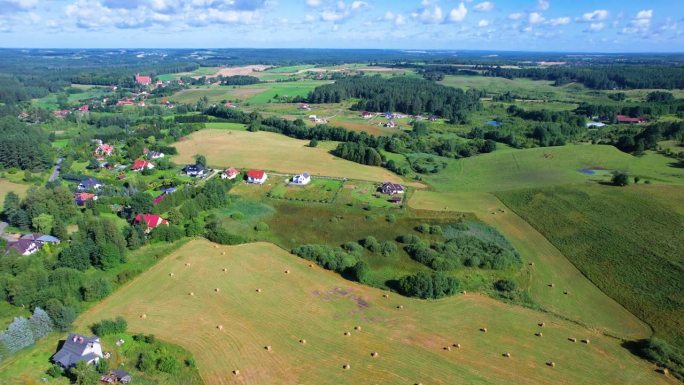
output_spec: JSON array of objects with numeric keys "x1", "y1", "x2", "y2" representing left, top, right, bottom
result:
[{"x1": 77, "y1": 240, "x2": 667, "y2": 385}]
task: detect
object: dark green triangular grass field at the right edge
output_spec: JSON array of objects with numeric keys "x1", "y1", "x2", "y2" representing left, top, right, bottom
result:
[{"x1": 498, "y1": 185, "x2": 684, "y2": 349}]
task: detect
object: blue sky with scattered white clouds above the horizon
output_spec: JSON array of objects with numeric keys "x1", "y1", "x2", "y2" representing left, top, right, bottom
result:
[{"x1": 0, "y1": 0, "x2": 684, "y2": 52}]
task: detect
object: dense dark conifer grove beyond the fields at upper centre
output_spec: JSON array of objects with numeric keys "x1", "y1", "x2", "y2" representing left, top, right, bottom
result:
[{"x1": 306, "y1": 76, "x2": 484, "y2": 123}]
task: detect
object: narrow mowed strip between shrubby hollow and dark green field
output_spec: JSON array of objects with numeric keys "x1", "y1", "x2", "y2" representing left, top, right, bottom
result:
[{"x1": 409, "y1": 190, "x2": 651, "y2": 339}]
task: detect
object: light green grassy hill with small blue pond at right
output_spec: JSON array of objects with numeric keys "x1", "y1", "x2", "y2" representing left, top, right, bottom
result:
[{"x1": 423, "y1": 144, "x2": 684, "y2": 192}]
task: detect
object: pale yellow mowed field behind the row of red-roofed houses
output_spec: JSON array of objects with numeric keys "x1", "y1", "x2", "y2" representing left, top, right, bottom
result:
[{"x1": 172, "y1": 129, "x2": 401, "y2": 182}]
